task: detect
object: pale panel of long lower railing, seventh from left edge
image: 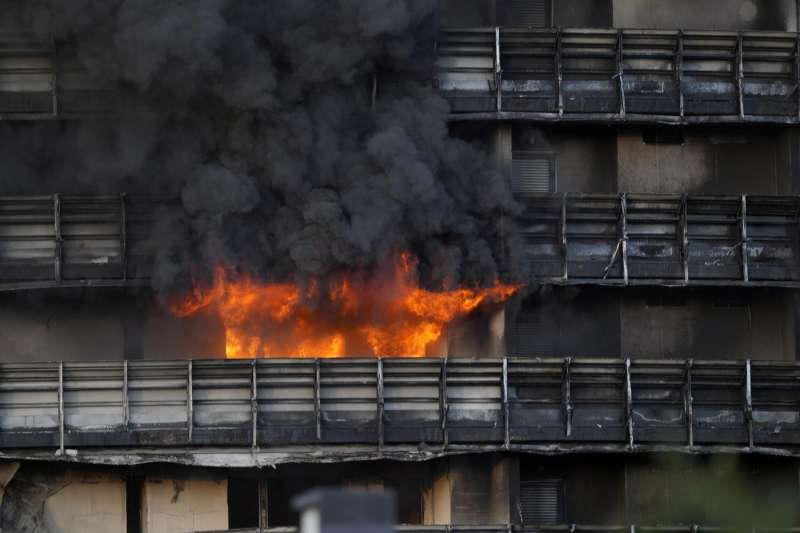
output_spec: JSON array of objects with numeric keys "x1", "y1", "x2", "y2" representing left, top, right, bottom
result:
[{"x1": 383, "y1": 359, "x2": 443, "y2": 443}]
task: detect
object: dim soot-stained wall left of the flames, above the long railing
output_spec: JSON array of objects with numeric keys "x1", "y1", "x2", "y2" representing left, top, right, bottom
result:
[{"x1": 0, "y1": 289, "x2": 225, "y2": 362}]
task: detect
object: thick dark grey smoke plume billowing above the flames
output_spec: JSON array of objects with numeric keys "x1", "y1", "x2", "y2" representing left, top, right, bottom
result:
[{"x1": 0, "y1": 0, "x2": 525, "y2": 289}]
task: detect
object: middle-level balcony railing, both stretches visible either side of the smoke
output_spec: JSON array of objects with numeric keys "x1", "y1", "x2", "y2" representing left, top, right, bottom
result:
[{"x1": 0, "y1": 194, "x2": 800, "y2": 290}]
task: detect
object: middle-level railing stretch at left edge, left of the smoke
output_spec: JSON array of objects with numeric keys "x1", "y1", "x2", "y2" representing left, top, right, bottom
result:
[{"x1": 0, "y1": 195, "x2": 158, "y2": 290}]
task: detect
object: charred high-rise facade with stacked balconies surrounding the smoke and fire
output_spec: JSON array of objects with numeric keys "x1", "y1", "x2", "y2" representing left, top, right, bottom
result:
[{"x1": 0, "y1": 0, "x2": 800, "y2": 533}]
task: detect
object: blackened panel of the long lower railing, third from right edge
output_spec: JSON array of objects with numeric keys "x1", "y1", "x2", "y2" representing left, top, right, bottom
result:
[{"x1": 631, "y1": 360, "x2": 689, "y2": 443}]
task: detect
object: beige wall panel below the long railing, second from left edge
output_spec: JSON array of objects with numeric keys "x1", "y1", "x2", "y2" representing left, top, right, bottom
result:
[{"x1": 142, "y1": 476, "x2": 228, "y2": 533}]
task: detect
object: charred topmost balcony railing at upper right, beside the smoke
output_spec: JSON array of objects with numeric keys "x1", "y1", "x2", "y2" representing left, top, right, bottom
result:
[{"x1": 436, "y1": 28, "x2": 800, "y2": 123}]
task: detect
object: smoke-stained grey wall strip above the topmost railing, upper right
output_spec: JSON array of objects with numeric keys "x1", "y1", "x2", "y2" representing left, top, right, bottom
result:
[{"x1": 614, "y1": 0, "x2": 797, "y2": 31}]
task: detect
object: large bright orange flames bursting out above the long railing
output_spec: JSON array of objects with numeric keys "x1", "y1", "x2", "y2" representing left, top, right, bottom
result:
[{"x1": 170, "y1": 253, "x2": 519, "y2": 358}]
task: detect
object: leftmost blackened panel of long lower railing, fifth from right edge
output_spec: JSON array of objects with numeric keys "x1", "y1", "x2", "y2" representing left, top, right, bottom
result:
[{"x1": 508, "y1": 359, "x2": 572, "y2": 442}]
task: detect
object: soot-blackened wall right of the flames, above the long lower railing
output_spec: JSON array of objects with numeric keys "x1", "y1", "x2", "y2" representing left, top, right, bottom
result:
[{"x1": 506, "y1": 287, "x2": 796, "y2": 361}]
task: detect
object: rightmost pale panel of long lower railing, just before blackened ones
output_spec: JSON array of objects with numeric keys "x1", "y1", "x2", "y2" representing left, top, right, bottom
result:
[{"x1": 446, "y1": 359, "x2": 504, "y2": 443}]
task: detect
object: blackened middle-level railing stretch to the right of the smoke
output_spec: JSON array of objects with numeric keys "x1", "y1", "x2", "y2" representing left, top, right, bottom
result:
[{"x1": 523, "y1": 194, "x2": 800, "y2": 287}]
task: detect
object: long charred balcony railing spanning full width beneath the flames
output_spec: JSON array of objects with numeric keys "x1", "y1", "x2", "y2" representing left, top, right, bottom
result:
[{"x1": 0, "y1": 358, "x2": 800, "y2": 452}]
